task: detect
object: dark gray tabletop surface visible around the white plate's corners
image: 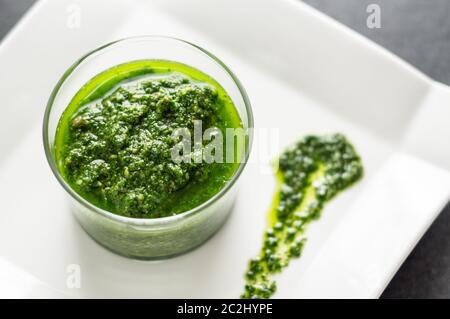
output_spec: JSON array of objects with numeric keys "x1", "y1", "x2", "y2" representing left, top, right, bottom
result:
[{"x1": 0, "y1": 0, "x2": 450, "y2": 298}]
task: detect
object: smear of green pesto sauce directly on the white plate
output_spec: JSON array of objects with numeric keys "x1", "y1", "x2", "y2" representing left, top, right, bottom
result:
[{"x1": 241, "y1": 134, "x2": 363, "y2": 298}]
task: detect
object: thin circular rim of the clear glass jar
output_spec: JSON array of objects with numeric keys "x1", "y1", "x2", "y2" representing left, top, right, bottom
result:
[{"x1": 43, "y1": 35, "x2": 254, "y2": 226}]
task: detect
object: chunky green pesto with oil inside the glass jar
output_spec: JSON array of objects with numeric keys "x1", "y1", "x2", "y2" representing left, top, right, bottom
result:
[{"x1": 54, "y1": 60, "x2": 242, "y2": 218}]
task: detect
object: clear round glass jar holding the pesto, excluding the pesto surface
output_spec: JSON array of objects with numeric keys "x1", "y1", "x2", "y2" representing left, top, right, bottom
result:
[{"x1": 43, "y1": 36, "x2": 253, "y2": 259}]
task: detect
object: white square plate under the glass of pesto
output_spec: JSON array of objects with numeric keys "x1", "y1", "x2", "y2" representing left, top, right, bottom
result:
[{"x1": 0, "y1": 0, "x2": 450, "y2": 298}]
